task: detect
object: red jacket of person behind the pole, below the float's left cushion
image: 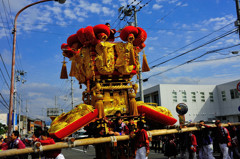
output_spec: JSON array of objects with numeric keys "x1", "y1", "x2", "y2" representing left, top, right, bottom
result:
[{"x1": 39, "y1": 138, "x2": 61, "y2": 158}]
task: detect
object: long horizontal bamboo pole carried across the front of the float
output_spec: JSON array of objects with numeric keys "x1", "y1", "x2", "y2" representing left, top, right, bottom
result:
[{"x1": 0, "y1": 123, "x2": 240, "y2": 157}]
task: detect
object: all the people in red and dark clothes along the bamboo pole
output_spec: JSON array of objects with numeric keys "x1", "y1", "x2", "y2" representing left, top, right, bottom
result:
[{"x1": 0, "y1": 111, "x2": 240, "y2": 159}]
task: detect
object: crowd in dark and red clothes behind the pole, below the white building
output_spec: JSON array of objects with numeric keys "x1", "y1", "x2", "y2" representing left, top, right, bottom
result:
[{"x1": 151, "y1": 120, "x2": 240, "y2": 159}]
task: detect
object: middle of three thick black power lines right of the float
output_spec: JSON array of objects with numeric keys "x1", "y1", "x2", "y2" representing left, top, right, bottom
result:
[{"x1": 151, "y1": 29, "x2": 238, "y2": 69}]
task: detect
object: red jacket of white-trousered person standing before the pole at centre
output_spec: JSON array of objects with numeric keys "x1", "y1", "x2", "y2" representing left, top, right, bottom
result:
[{"x1": 135, "y1": 129, "x2": 149, "y2": 150}]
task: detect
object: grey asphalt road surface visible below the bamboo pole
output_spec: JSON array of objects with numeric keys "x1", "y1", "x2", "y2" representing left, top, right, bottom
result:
[{"x1": 62, "y1": 145, "x2": 219, "y2": 159}]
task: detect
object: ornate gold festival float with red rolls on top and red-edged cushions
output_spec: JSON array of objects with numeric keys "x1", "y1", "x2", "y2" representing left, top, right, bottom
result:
[{"x1": 49, "y1": 24, "x2": 177, "y2": 139}]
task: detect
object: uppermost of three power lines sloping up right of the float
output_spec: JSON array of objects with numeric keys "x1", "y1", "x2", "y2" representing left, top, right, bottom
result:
[{"x1": 149, "y1": 22, "x2": 233, "y2": 64}]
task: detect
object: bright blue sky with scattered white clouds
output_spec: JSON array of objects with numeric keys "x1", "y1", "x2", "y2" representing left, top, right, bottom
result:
[{"x1": 0, "y1": 0, "x2": 240, "y2": 122}]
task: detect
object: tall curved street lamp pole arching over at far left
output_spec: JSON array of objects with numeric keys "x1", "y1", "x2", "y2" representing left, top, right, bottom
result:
[{"x1": 8, "y1": 0, "x2": 66, "y2": 136}]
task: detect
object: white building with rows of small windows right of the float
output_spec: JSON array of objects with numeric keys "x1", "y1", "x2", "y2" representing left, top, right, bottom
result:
[{"x1": 136, "y1": 80, "x2": 240, "y2": 124}]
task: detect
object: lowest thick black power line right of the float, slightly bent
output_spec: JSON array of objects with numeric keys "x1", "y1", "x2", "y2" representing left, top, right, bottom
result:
[{"x1": 143, "y1": 44, "x2": 240, "y2": 82}]
